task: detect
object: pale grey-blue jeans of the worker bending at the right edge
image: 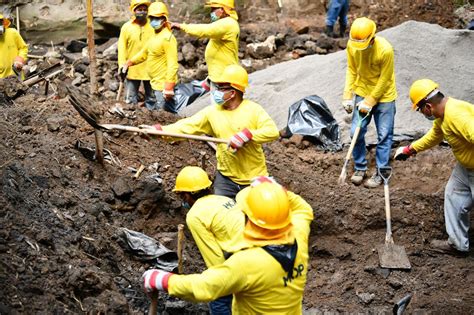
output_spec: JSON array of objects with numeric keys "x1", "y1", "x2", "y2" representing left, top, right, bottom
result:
[{"x1": 444, "y1": 162, "x2": 474, "y2": 251}]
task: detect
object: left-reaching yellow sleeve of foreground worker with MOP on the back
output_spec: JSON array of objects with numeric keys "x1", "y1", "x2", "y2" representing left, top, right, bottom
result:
[{"x1": 168, "y1": 256, "x2": 247, "y2": 302}]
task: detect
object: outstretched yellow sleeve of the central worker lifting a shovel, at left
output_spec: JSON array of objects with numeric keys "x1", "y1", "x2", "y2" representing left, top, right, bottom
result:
[{"x1": 163, "y1": 107, "x2": 212, "y2": 140}]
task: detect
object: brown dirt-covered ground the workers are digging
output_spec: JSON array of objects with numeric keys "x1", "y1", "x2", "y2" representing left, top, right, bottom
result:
[{"x1": 0, "y1": 91, "x2": 474, "y2": 314}]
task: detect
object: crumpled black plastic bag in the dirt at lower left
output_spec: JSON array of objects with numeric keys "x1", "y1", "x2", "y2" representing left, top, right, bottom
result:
[{"x1": 121, "y1": 228, "x2": 178, "y2": 271}]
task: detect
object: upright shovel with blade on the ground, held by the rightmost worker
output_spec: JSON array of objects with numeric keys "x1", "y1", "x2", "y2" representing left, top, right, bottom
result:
[{"x1": 377, "y1": 167, "x2": 411, "y2": 270}]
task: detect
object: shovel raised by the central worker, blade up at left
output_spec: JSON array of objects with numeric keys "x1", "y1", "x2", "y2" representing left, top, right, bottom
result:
[{"x1": 66, "y1": 87, "x2": 229, "y2": 143}]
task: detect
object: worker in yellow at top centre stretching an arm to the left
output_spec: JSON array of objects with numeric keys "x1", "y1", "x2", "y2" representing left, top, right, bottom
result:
[{"x1": 171, "y1": 0, "x2": 240, "y2": 90}]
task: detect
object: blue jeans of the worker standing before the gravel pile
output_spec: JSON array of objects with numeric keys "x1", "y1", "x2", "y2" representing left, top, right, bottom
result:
[{"x1": 351, "y1": 95, "x2": 396, "y2": 171}]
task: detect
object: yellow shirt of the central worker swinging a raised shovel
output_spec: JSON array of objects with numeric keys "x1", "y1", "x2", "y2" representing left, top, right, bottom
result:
[{"x1": 163, "y1": 99, "x2": 279, "y2": 185}]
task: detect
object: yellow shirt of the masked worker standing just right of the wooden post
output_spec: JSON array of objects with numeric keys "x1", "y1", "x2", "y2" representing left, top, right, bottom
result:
[{"x1": 118, "y1": 18, "x2": 155, "y2": 81}]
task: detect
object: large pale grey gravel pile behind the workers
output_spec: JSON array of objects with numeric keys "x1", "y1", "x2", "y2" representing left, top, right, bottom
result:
[{"x1": 183, "y1": 21, "x2": 474, "y2": 142}]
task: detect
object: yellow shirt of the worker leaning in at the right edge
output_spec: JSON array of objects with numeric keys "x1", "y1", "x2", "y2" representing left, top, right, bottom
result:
[{"x1": 411, "y1": 97, "x2": 474, "y2": 170}]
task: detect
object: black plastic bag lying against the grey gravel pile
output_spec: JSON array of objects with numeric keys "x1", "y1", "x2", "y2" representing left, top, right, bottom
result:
[{"x1": 287, "y1": 95, "x2": 342, "y2": 151}]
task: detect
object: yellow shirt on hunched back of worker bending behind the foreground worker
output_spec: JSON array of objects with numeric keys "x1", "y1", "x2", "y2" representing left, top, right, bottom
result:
[{"x1": 186, "y1": 195, "x2": 245, "y2": 268}]
